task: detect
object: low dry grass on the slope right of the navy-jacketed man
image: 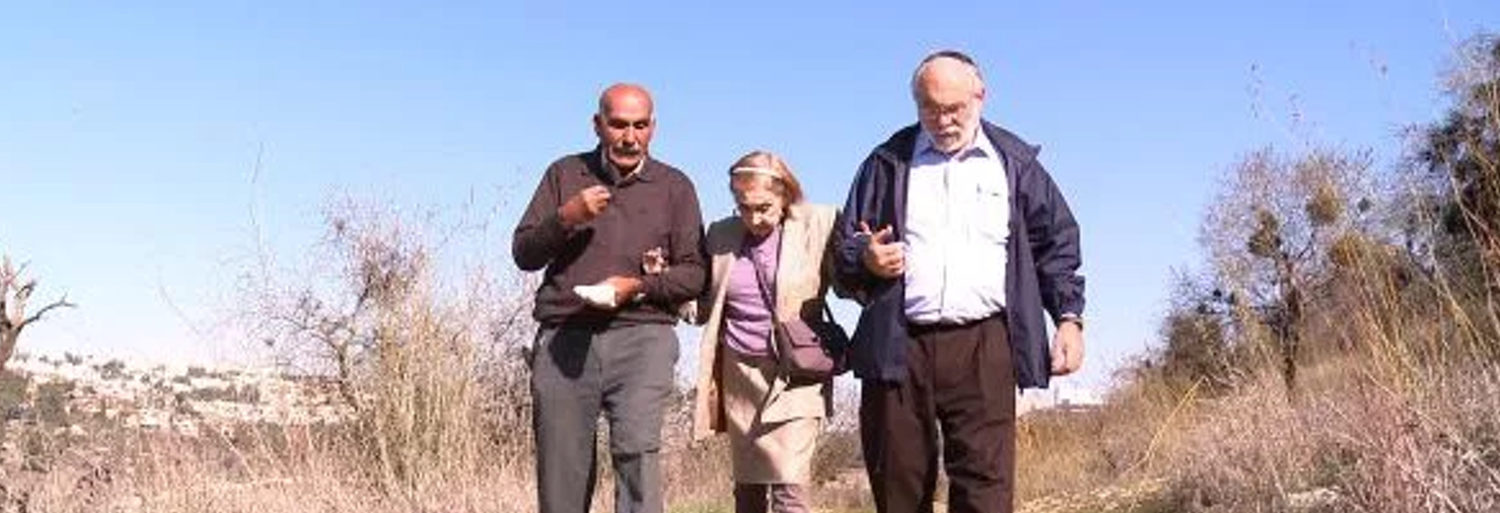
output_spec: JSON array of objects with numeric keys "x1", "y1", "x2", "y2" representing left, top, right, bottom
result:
[{"x1": 1019, "y1": 316, "x2": 1500, "y2": 512}]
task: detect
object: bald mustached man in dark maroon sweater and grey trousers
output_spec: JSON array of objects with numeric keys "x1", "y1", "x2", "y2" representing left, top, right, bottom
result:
[{"x1": 512, "y1": 84, "x2": 705, "y2": 513}]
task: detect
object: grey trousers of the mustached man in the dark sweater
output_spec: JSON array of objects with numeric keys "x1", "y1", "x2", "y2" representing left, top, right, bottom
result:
[{"x1": 531, "y1": 324, "x2": 678, "y2": 513}]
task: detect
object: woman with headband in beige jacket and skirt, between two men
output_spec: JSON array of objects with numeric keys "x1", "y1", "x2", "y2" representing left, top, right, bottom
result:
[{"x1": 693, "y1": 152, "x2": 837, "y2": 513}]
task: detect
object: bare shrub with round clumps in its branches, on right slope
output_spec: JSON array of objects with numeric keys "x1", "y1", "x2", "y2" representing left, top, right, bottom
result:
[{"x1": 1200, "y1": 149, "x2": 1376, "y2": 390}]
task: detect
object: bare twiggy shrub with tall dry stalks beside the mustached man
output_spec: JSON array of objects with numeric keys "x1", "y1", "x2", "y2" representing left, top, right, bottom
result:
[{"x1": 246, "y1": 195, "x2": 546, "y2": 500}]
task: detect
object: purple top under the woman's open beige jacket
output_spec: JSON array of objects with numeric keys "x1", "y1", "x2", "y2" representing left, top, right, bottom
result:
[{"x1": 723, "y1": 227, "x2": 782, "y2": 356}]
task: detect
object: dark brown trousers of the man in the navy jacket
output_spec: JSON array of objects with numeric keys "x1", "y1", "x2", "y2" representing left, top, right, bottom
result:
[{"x1": 860, "y1": 315, "x2": 1016, "y2": 513}]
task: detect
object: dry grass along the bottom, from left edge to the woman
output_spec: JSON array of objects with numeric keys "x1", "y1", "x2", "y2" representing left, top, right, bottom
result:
[{"x1": 0, "y1": 372, "x2": 756, "y2": 513}]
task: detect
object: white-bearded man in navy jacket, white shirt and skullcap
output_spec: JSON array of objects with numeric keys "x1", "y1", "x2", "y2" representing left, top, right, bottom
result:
[{"x1": 836, "y1": 51, "x2": 1083, "y2": 513}]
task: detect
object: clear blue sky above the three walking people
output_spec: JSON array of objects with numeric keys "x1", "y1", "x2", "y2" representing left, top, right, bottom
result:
[{"x1": 0, "y1": 0, "x2": 1500, "y2": 383}]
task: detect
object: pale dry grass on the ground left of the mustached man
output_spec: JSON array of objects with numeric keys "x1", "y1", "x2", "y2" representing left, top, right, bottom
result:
[{"x1": 0, "y1": 420, "x2": 534, "y2": 512}]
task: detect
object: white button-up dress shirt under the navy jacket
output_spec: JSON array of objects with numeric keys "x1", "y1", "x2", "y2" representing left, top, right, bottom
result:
[{"x1": 902, "y1": 131, "x2": 1011, "y2": 324}]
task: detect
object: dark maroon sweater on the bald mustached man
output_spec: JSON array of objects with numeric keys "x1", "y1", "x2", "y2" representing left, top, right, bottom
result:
[{"x1": 512, "y1": 149, "x2": 707, "y2": 326}]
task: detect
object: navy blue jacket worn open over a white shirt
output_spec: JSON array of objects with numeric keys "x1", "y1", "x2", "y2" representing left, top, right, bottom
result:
[{"x1": 834, "y1": 122, "x2": 1083, "y2": 389}]
